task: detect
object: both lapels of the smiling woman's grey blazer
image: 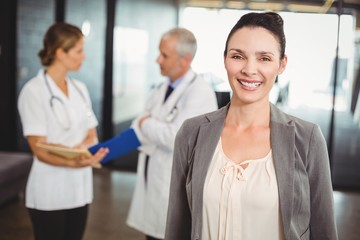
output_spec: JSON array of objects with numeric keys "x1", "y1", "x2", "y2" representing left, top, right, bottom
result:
[{"x1": 197, "y1": 103, "x2": 295, "y2": 237}]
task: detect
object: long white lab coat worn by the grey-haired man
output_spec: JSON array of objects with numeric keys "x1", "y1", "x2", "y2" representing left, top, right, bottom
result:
[{"x1": 127, "y1": 70, "x2": 218, "y2": 238}]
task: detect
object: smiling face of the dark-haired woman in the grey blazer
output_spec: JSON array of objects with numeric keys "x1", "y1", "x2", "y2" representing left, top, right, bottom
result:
[{"x1": 224, "y1": 27, "x2": 287, "y2": 104}]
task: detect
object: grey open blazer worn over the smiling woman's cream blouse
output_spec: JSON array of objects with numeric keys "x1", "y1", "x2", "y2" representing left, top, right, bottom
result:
[{"x1": 165, "y1": 104, "x2": 338, "y2": 240}]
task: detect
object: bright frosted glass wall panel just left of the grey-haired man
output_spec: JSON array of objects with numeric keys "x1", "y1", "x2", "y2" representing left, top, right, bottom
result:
[{"x1": 109, "y1": 0, "x2": 178, "y2": 171}]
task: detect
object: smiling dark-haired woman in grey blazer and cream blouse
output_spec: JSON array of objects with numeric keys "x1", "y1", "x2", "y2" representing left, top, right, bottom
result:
[{"x1": 165, "y1": 12, "x2": 337, "y2": 240}]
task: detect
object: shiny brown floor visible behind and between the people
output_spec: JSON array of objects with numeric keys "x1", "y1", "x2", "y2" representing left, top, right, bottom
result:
[{"x1": 0, "y1": 167, "x2": 360, "y2": 240}]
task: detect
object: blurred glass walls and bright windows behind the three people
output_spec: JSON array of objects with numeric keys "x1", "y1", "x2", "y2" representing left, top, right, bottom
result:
[{"x1": 0, "y1": 0, "x2": 360, "y2": 190}]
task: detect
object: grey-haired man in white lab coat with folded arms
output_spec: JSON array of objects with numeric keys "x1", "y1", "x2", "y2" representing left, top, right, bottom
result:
[{"x1": 127, "y1": 28, "x2": 217, "y2": 239}]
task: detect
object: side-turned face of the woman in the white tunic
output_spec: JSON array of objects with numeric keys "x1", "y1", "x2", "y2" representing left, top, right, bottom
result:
[{"x1": 60, "y1": 38, "x2": 85, "y2": 71}]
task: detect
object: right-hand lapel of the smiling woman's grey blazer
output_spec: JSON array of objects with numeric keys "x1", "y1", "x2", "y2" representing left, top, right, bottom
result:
[{"x1": 270, "y1": 106, "x2": 295, "y2": 239}]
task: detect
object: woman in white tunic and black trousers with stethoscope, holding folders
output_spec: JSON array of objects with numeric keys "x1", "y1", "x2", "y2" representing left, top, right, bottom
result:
[{"x1": 18, "y1": 23, "x2": 108, "y2": 240}]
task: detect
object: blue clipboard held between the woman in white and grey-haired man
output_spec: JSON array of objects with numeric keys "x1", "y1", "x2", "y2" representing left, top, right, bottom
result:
[{"x1": 88, "y1": 128, "x2": 141, "y2": 164}]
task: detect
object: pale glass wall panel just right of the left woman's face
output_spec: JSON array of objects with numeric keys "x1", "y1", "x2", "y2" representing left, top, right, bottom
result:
[{"x1": 65, "y1": 0, "x2": 106, "y2": 127}]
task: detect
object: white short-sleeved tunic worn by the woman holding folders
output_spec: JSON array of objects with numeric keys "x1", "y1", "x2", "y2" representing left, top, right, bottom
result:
[{"x1": 18, "y1": 69, "x2": 98, "y2": 211}]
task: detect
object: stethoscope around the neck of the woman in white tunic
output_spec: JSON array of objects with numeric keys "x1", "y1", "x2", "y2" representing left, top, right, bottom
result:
[{"x1": 44, "y1": 71, "x2": 92, "y2": 130}]
